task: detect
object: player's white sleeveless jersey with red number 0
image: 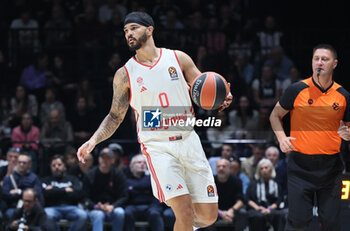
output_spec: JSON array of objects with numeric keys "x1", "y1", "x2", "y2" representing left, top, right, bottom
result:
[{"x1": 124, "y1": 48, "x2": 193, "y2": 143}]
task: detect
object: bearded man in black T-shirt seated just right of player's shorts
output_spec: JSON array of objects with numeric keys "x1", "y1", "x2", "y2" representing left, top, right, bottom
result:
[{"x1": 201, "y1": 159, "x2": 244, "y2": 231}]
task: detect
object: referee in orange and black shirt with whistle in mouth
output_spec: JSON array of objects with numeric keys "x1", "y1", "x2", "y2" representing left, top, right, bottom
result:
[{"x1": 270, "y1": 44, "x2": 350, "y2": 231}]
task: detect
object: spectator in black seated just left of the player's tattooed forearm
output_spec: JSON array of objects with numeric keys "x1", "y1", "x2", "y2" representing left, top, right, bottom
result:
[{"x1": 70, "y1": 96, "x2": 97, "y2": 146}]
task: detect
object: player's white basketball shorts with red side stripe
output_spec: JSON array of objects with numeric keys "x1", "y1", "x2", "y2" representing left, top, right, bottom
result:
[{"x1": 142, "y1": 131, "x2": 218, "y2": 203}]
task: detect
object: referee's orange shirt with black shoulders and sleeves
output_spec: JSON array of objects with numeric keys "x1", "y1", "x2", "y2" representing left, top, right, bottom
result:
[{"x1": 279, "y1": 77, "x2": 350, "y2": 155}]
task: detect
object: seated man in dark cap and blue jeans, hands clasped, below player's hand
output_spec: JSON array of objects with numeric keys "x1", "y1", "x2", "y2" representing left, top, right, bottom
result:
[{"x1": 84, "y1": 148, "x2": 128, "y2": 231}]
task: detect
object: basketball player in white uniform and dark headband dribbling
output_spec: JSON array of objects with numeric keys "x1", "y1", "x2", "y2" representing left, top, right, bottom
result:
[{"x1": 77, "y1": 12, "x2": 232, "y2": 231}]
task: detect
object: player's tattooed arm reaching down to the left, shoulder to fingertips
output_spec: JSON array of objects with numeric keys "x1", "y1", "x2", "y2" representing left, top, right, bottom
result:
[{"x1": 77, "y1": 67, "x2": 130, "y2": 163}]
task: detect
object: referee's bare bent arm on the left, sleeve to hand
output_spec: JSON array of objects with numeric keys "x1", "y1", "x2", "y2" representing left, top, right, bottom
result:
[{"x1": 270, "y1": 102, "x2": 295, "y2": 152}]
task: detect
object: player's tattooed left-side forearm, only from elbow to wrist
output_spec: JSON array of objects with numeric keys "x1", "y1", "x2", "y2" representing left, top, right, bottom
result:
[{"x1": 91, "y1": 112, "x2": 123, "y2": 144}]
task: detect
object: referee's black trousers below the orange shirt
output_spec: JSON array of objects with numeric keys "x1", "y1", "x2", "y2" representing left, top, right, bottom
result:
[{"x1": 286, "y1": 152, "x2": 343, "y2": 231}]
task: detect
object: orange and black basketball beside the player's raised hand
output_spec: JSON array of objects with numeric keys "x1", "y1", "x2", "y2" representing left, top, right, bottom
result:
[{"x1": 191, "y1": 72, "x2": 230, "y2": 110}]
